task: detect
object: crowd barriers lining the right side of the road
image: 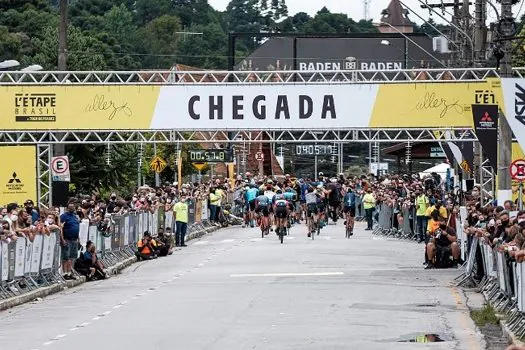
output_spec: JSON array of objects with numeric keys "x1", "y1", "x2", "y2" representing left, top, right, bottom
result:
[{"x1": 373, "y1": 203, "x2": 525, "y2": 338}]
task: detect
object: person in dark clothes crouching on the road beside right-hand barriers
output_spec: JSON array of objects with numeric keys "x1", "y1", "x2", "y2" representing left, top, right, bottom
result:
[{"x1": 426, "y1": 217, "x2": 460, "y2": 269}]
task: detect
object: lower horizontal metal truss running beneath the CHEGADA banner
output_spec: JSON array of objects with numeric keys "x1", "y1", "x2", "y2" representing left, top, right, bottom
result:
[{"x1": 0, "y1": 128, "x2": 478, "y2": 145}]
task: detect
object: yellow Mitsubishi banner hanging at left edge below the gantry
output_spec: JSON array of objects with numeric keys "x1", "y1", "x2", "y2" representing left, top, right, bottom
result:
[{"x1": 0, "y1": 146, "x2": 38, "y2": 206}]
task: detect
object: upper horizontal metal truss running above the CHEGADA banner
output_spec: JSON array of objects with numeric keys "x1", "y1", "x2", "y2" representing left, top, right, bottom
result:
[{"x1": 0, "y1": 68, "x2": 508, "y2": 86}]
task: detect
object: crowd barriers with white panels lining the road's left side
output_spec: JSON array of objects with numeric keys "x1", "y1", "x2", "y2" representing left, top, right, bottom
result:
[{"x1": 0, "y1": 200, "x2": 211, "y2": 300}]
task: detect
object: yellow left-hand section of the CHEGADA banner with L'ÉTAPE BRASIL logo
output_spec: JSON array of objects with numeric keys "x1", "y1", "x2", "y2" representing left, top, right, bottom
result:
[{"x1": 0, "y1": 85, "x2": 160, "y2": 130}]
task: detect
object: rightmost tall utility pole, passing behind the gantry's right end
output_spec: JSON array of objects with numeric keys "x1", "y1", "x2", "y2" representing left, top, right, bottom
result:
[{"x1": 497, "y1": 0, "x2": 514, "y2": 205}]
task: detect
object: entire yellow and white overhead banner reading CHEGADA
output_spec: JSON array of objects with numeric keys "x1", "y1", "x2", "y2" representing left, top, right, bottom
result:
[{"x1": 0, "y1": 80, "x2": 500, "y2": 131}]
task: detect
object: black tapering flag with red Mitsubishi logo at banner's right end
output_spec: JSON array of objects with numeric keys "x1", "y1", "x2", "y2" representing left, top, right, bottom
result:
[{"x1": 472, "y1": 105, "x2": 499, "y2": 173}]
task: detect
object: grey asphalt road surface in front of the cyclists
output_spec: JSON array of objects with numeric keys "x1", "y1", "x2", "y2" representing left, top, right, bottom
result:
[{"x1": 0, "y1": 222, "x2": 483, "y2": 350}]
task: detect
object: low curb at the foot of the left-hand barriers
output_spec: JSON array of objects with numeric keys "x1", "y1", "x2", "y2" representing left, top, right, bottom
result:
[{"x1": 0, "y1": 226, "x2": 219, "y2": 311}]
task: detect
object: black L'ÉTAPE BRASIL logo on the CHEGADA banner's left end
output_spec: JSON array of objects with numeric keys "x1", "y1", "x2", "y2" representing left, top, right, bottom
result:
[{"x1": 15, "y1": 93, "x2": 57, "y2": 122}]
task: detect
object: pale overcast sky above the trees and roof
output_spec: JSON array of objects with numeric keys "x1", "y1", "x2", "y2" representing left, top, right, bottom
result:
[{"x1": 208, "y1": 0, "x2": 504, "y2": 24}]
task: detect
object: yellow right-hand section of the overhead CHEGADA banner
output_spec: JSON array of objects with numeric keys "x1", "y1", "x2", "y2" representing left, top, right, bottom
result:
[{"x1": 370, "y1": 79, "x2": 502, "y2": 128}]
